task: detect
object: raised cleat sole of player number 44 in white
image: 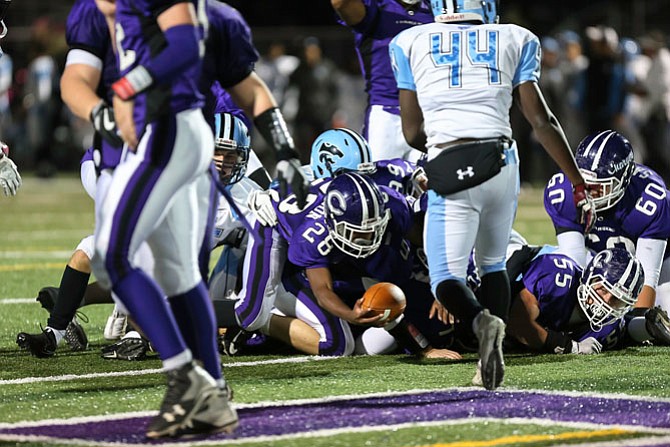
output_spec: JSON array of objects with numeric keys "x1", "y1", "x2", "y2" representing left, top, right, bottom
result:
[{"x1": 475, "y1": 309, "x2": 505, "y2": 390}]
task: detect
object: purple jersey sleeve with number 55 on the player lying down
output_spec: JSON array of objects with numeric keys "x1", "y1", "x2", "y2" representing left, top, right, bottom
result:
[{"x1": 522, "y1": 254, "x2": 581, "y2": 331}]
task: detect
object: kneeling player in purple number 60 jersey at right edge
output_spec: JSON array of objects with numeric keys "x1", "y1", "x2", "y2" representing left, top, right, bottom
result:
[{"x1": 544, "y1": 130, "x2": 670, "y2": 341}]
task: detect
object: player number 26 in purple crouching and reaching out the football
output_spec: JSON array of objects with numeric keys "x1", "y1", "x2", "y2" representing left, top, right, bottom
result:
[{"x1": 235, "y1": 172, "x2": 458, "y2": 358}]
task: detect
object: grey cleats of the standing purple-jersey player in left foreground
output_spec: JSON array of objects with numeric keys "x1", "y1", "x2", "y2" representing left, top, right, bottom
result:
[{"x1": 146, "y1": 362, "x2": 238, "y2": 439}]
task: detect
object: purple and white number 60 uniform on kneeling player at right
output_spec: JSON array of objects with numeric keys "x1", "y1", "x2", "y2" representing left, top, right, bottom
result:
[{"x1": 544, "y1": 164, "x2": 670, "y2": 300}]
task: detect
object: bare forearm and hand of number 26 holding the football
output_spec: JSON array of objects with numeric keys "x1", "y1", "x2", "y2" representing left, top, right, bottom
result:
[{"x1": 305, "y1": 267, "x2": 383, "y2": 325}]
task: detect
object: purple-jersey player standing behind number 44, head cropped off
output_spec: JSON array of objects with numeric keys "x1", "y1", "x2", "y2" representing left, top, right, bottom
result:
[{"x1": 330, "y1": 0, "x2": 433, "y2": 162}]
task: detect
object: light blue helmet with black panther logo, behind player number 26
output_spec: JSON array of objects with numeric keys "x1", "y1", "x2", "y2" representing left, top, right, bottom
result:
[{"x1": 309, "y1": 127, "x2": 372, "y2": 179}]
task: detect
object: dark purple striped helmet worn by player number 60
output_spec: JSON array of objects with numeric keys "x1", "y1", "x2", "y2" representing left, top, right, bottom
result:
[{"x1": 575, "y1": 130, "x2": 635, "y2": 211}]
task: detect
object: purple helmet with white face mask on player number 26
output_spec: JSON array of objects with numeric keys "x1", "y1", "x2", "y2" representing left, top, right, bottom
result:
[{"x1": 325, "y1": 172, "x2": 391, "y2": 258}]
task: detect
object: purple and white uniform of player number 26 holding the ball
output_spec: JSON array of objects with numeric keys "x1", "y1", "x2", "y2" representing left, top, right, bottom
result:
[{"x1": 235, "y1": 179, "x2": 412, "y2": 355}]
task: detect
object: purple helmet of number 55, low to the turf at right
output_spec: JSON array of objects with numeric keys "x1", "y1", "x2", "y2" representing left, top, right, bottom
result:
[{"x1": 577, "y1": 247, "x2": 644, "y2": 331}]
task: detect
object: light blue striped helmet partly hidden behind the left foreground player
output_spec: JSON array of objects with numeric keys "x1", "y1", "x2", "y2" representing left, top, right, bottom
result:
[{"x1": 214, "y1": 112, "x2": 251, "y2": 185}]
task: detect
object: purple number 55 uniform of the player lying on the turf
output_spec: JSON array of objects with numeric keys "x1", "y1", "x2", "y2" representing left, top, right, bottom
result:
[{"x1": 512, "y1": 253, "x2": 625, "y2": 349}]
